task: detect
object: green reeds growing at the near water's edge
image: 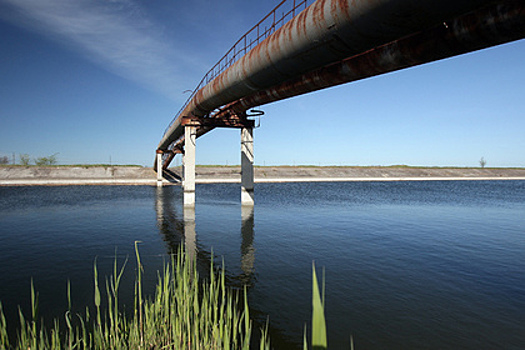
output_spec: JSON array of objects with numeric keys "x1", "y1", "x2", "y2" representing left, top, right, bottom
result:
[{"x1": 0, "y1": 242, "x2": 327, "y2": 350}]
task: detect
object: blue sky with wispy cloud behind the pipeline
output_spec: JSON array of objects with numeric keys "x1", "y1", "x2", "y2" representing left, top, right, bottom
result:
[{"x1": 0, "y1": 0, "x2": 525, "y2": 167}]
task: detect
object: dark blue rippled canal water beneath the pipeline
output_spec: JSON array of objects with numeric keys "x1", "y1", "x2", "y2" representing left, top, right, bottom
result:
[{"x1": 0, "y1": 181, "x2": 525, "y2": 349}]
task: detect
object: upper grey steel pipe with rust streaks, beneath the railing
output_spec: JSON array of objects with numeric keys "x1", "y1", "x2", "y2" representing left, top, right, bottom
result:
[{"x1": 158, "y1": 0, "x2": 520, "y2": 150}]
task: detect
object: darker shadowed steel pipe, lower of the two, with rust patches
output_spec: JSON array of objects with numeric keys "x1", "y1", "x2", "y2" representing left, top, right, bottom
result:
[{"x1": 228, "y1": 0, "x2": 525, "y2": 113}]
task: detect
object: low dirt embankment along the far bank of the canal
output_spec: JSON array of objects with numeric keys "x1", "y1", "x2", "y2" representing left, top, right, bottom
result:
[{"x1": 0, "y1": 166, "x2": 525, "y2": 186}]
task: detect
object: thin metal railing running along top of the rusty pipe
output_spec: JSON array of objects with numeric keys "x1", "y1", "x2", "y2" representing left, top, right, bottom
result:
[{"x1": 164, "y1": 0, "x2": 314, "y2": 135}]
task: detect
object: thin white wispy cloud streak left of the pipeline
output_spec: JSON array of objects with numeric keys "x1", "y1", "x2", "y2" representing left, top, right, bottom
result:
[{"x1": 0, "y1": 0, "x2": 195, "y2": 100}]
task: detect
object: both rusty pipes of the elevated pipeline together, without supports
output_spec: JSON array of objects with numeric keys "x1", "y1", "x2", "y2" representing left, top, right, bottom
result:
[{"x1": 158, "y1": 0, "x2": 524, "y2": 167}]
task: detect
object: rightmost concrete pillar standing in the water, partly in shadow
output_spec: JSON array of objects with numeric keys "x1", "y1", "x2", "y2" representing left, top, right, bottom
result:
[{"x1": 241, "y1": 128, "x2": 255, "y2": 205}]
